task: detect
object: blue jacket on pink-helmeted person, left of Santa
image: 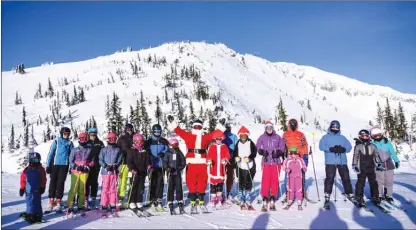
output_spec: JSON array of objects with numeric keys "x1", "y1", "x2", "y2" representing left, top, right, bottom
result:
[{"x1": 144, "y1": 134, "x2": 169, "y2": 168}]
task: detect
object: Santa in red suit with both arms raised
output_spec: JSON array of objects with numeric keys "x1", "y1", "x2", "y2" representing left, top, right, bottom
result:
[{"x1": 168, "y1": 115, "x2": 225, "y2": 208}]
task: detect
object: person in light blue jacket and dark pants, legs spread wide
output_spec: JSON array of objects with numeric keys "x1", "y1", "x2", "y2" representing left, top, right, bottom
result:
[{"x1": 319, "y1": 120, "x2": 354, "y2": 209}]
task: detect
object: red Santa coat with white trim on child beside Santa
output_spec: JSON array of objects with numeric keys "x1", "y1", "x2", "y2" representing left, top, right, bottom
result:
[{"x1": 207, "y1": 144, "x2": 230, "y2": 184}]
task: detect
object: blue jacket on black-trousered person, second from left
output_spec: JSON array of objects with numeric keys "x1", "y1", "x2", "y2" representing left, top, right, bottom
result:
[{"x1": 46, "y1": 137, "x2": 74, "y2": 167}]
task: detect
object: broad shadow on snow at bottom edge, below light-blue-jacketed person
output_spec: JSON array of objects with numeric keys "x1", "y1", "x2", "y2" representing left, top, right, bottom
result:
[{"x1": 309, "y1": 202, "x2": 348, "y2": 229}]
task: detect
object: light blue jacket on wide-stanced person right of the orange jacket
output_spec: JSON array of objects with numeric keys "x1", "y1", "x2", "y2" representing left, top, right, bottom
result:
[{"x1": 319, "y1": 129, "x2": 352, "y2": 165}]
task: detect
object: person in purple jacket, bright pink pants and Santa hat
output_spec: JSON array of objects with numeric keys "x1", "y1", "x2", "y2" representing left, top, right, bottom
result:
[{"x1": 256, "y1": 121, "x2": 285, "y2": 211}]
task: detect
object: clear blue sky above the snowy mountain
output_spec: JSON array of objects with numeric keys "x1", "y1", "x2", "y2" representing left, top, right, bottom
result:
[{"x1": 1, "y1": 2, "x2": 416, "y2": 93}]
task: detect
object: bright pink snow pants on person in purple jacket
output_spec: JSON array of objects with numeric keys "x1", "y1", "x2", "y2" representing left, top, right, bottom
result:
[{"x1": 261, "y1": 165, "x2": 281, "y2": 198}]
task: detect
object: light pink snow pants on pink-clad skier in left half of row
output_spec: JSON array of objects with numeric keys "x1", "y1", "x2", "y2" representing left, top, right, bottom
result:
[{"x1": 100, "y1": 174, "x2": 118, "y2": 206}]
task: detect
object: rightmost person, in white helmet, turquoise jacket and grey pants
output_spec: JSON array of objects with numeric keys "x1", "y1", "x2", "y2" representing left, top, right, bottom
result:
[{"x1": 371, "y1": 127, "x2": 400, "y2": 203}]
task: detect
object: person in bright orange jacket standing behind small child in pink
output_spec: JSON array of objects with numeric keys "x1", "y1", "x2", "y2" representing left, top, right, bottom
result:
[{"x1": 283, "y1": 118, "x2": 308, "y2": 202}]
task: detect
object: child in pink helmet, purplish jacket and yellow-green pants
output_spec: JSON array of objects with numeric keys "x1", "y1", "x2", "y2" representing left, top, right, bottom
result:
[{"x1": 66, "y1": 132, "x2": 94, "y2": 216}]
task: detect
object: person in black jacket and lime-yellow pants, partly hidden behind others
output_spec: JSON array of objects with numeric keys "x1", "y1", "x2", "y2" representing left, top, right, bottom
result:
[{"x1": 117, "y1": 124, "x2": 135, "y2": 206}]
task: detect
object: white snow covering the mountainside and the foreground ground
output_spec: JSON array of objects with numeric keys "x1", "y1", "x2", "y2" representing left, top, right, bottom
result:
[{"x1": 1, "y1": 42, "x2": 416, "y2": 229}]
